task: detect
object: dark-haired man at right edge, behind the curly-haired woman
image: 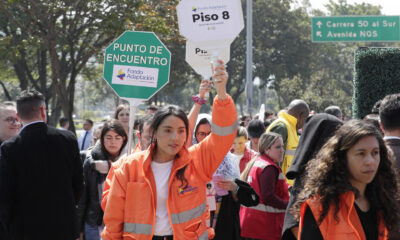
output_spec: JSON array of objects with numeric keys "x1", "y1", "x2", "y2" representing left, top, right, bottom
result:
[{"x1": 379, "y1": 94, "x2": 400, "y2": 240}]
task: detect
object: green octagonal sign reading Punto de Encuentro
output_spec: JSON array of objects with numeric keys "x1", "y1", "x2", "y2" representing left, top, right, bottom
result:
[{"x1": 103, "y1": 31, "x2": 171, "y2": 100}]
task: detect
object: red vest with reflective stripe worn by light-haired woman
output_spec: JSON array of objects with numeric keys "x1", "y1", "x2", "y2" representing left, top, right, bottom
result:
[{"x1": 240, "y1": 155, "x2": 289, "y2": 240}]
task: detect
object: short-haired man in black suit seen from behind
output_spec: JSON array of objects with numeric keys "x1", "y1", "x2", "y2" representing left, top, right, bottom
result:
[{"x1": 0, "y1": 90, "x2": 83, "y2": 240}]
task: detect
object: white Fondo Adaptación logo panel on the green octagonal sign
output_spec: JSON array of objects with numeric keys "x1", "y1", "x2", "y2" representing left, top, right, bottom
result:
[{"x1": 112, "y1": 65, "x2": 158, "y2": 88}]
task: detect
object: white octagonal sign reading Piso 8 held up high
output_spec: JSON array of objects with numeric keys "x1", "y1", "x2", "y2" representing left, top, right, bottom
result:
[{"x1": 177, "y1": 0, "x2": 244, "y2": 43}]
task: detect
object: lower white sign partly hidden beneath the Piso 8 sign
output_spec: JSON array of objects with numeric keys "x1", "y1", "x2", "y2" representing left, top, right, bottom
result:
[{"x1": 186, "y1": 41, "x2": 230, "y2": 77}]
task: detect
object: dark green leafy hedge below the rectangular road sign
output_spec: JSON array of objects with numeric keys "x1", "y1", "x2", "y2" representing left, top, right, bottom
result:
[{"x1": 353, "y1": 48, "x2": 400, "y2": 118}]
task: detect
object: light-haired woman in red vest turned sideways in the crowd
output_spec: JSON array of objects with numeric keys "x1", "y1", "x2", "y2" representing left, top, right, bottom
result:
[{"x1": 240, "y1": 132, "x2": 289, "y2": 240}]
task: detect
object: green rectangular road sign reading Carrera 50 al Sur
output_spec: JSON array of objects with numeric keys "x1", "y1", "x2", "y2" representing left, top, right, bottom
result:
[{"x1": 311, "y1": 16, "x2": 400, "y2": 42}]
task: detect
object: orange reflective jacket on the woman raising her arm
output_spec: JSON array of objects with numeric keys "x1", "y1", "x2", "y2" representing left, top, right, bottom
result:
[{"x1": 102, "y1": 97, "x2": 237, "y2": 240}]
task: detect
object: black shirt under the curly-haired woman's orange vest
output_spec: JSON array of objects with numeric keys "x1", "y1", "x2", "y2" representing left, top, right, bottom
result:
[{"x1": 300, "y1": 203, "x2": 378, "y2": 240}]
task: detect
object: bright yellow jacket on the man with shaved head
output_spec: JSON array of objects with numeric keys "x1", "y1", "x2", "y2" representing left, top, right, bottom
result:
[{"x1": 267, "y1": 112, "x2": 299, "y2": 186}]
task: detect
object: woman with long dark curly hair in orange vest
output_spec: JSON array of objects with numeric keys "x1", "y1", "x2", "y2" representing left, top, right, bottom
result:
[{"x1": 292, "y1": 120, "x2": 399, "y2": 240}]
